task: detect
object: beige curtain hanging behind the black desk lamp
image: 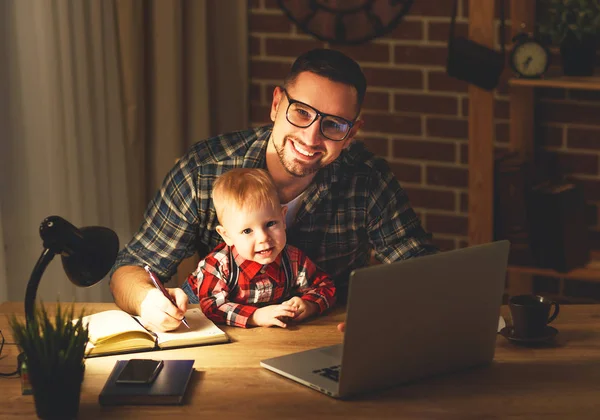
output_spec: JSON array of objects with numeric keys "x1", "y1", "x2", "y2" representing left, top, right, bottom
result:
[{"x1": 0, "y1": 0, "x2": 247, "y2": 301}]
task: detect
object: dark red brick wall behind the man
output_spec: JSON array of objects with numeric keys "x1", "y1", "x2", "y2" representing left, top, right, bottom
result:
[{"x1": 249, "y1": 0, "x2": 600, "y2": 260}]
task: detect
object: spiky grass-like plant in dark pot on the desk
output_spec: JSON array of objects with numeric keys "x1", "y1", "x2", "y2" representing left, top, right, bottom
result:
[{"x1": 9, "y1": 304, "x2": 89, "y2": 419}]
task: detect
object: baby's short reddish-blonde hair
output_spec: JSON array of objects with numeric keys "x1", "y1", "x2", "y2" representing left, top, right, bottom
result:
[{"x1": 212, "y1": 168, "x2": 281, "y2": 224}]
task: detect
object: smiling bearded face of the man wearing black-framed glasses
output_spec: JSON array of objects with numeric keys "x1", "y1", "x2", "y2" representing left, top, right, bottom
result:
[{"x1": 271, "y1": 72, "x2": 362, "y2": 177}]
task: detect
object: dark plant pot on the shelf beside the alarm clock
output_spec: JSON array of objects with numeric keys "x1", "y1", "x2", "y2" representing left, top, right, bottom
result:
[{"x1": 560, "y1": 35, "x2": 597, "y2": 76}]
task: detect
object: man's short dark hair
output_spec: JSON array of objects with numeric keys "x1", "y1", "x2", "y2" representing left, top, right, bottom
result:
[{"x1": 284, "y1": 48, "x2": 367, "y2": 110}]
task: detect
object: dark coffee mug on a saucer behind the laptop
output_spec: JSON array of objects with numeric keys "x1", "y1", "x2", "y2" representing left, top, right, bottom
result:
[{"x1": 508, "y1": 295, "x2": 559, "y2": 338}]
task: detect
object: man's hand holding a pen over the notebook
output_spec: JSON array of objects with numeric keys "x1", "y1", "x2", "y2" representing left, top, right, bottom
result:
[{"x1": 140, "y1": 288, "x2": 188, "y2": 332}]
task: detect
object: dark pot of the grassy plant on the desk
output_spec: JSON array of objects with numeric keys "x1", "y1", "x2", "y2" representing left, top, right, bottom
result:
[{"x1": 29, "y1": 367, "x2": 84, "y2": 420}]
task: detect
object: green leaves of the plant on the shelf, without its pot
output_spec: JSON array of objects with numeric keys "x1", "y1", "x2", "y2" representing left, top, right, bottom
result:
[{"x1": 537, "y1": 0, "x2": 600, "y2": 44}]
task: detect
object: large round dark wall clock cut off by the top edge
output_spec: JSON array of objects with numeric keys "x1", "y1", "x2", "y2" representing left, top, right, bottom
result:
[{"x1": 278, "y1": 0, "x2": 414, "y2": 44}]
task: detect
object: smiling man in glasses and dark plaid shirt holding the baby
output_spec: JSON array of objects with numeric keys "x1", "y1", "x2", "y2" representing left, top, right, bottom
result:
[{"x1": 110, "y1": 49, "x2": 435, "y2": 331}]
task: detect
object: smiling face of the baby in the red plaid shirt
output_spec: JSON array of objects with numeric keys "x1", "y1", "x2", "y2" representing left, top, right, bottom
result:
[{"x1": 219, "y1": 202, "x2": 287, "y2": 264}]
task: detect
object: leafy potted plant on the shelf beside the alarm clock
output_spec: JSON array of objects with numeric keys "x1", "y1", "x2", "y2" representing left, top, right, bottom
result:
[{"x1": 537, "y1": 0, "x2": 600, "y2": 76}]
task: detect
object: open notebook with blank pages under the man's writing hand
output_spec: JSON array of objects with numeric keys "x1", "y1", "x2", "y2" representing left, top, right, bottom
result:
[{"x1": 78, "y1": 308, "x2": 229, "y2": 357}]
